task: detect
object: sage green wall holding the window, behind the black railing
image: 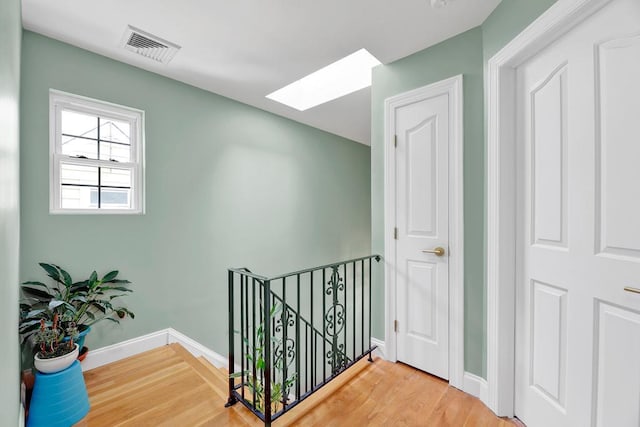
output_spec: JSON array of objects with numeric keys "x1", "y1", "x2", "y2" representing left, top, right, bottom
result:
[{"x1": 21, "y1": 32, "x2": 371, "y2": 354}]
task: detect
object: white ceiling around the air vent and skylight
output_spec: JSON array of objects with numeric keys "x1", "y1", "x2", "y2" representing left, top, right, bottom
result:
[{"x1": 22, "y1": 0, "x2": 500, "y2": 144}]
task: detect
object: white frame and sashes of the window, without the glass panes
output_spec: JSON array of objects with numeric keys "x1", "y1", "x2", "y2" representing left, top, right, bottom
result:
[{"x1": 49, "y1": 89, "x2": 145, "y2": 215}]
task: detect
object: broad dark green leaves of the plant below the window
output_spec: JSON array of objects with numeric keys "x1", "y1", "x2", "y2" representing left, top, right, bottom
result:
[{"x1": 20, "y1": 263, "x2": 135, "y2": 358}]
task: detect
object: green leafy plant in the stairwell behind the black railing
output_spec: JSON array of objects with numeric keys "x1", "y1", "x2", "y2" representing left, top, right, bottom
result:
[{"x1": 229, "y1": 304, "x2": 296, "y2": 413}]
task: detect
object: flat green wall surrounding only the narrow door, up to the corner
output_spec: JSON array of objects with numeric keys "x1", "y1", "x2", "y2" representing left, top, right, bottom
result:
[{"x1": 371, "y1": 28, "x2": 486, "y2": 375}]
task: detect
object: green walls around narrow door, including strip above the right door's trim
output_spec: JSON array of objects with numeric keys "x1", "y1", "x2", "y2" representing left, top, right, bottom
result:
[{"x1": 371, "y1": 0, "x2": 555, "y2": 378}]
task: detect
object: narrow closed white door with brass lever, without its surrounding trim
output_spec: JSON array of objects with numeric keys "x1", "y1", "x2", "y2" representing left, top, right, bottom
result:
[{"x1": 392, "y1": 93, "x2": 450, "y2": 379}]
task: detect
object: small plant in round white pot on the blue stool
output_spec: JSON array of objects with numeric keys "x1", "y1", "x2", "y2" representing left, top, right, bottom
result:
[{"x1": 33, "y1": 313, "x2": 78, "y2": 374}]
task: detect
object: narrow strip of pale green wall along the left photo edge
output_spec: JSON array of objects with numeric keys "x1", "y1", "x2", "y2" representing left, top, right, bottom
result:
[{"x1": 0, "y1": 0, "x2": 22, "y2": 426}]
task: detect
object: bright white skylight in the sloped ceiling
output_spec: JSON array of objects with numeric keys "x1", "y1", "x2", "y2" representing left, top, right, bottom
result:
[{"x1": 267, "y1": 49, "x2": 380, "y2": 111}]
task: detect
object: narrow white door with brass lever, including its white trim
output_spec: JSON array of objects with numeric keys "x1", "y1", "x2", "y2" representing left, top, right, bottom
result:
[{"x1": 385, "y1": 76, "x2": 464, "y2": 388}]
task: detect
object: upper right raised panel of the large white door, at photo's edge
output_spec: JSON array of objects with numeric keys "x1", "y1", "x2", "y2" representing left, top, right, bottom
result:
[{"x1": 596, "y1": 36, "x2": 640, "y2": 258}]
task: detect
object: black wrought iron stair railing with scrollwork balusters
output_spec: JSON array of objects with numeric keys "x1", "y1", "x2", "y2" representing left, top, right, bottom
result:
[{"x1": 226, "y1": 255, "x2": 380, "y2": 426}]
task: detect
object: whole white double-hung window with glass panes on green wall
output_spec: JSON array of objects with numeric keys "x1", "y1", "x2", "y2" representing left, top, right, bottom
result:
[{"x1": 49, "y1": 90, "x2": 144, "y2": 214}]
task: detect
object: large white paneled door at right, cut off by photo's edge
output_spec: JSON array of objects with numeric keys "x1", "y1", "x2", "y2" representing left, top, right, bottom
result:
[{"x1": 515, "y1": 0, "x2": 640, "y2": 427}]
